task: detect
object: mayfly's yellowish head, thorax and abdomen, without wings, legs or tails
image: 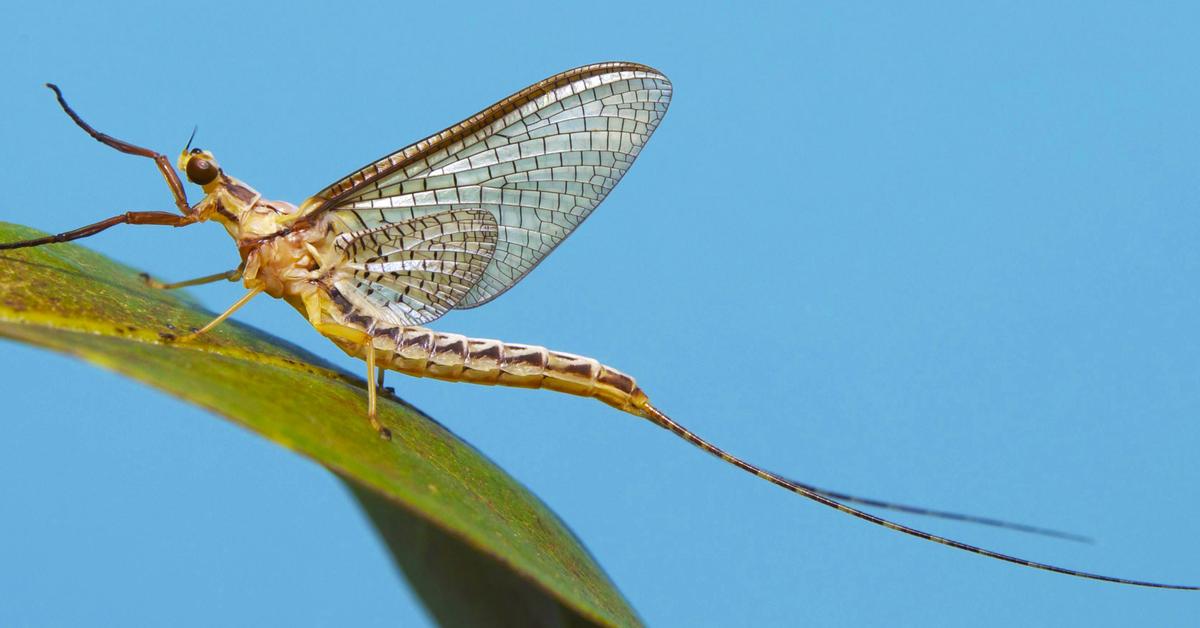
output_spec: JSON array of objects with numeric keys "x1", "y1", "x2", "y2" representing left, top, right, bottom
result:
[{"x1": 180, "y1": 152, "x2": 647, "y2": 417}]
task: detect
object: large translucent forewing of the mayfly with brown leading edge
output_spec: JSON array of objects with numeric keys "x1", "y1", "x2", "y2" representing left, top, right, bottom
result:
[{"x1": 304, "y1": 62, "x2": 671, "y2": 309}]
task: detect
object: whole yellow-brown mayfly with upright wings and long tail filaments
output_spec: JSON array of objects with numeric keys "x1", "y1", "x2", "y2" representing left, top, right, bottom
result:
[{"x1": 0, "y1": 62, "x2": 1200, "y2": 590}]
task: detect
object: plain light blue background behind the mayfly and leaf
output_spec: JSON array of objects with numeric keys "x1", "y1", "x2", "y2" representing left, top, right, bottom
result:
[{"x1": 0, "y1": 2, "x2": 1200, "y2": 626}]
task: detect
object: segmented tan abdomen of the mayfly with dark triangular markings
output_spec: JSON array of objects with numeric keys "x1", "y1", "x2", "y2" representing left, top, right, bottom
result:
[{"x1": 374, "y1": 327, "x2": 646, "y2": 414}]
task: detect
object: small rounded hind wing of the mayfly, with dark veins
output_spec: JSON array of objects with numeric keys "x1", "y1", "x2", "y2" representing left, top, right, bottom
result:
[{"x1": 332, "y1": 209, "x2": 497, "y2": 327}]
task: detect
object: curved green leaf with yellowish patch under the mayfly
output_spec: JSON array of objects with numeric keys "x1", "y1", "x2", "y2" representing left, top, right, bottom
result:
[{"x1": 0, "y1": 223, "x2": 640, "y2": 626}]
